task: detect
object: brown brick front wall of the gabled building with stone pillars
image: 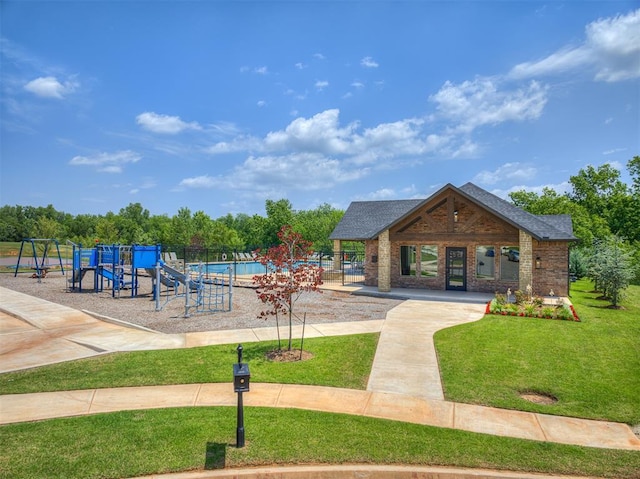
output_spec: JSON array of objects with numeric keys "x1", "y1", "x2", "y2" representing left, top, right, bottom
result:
[{"x1": 365, "y1": 192, "x2": 568, "y2": 295}]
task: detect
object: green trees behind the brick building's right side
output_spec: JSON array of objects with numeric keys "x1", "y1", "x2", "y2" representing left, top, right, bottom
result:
[{"x1": 509, "y1": 156, "x2": 640, "y2": 286}]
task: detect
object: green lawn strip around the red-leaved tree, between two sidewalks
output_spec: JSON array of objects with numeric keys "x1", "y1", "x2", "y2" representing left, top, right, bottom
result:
[{"x1": 0, "y1": 334, "x2": 379, "y2": 394}]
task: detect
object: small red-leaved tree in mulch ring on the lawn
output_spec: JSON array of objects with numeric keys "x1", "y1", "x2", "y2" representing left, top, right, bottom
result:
[{"x1": 253, "y1": 225, "x2": 323, "y2": 351}]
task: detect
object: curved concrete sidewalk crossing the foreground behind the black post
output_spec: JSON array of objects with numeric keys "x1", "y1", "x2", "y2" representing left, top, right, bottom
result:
[{"x1": 0, "y1": 383, "x2": 640, "y2": 451}]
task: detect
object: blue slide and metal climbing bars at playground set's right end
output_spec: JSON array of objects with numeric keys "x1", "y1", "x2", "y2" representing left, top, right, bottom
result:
[{"x1": 147, "y1": 260, "x2": 233, "y2": 318}]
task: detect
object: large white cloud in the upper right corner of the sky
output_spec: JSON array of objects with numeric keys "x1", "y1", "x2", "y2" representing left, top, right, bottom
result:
[{"x1": 509, "y1": 9, "x2": 640, "y2": 82}]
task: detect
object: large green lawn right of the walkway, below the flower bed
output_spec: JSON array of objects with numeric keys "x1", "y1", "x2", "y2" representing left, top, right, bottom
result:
[{"x1": 435, "y1": 281, "x2": 640, "y2": 425}]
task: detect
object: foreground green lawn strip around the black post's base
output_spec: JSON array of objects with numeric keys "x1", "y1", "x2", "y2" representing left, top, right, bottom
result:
[{"x1": 0, "y1": 407, "x2": 640, "y2": 479}]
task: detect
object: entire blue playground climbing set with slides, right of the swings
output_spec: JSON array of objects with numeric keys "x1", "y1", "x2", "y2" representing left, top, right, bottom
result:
[{"x1": 68, "y1": 243, "x2": 233, "y2": 317}]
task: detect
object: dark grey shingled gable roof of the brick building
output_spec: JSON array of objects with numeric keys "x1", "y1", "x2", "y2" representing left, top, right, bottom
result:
[{"x1": 329, "y1": 183, "x2": 577, "y2": 241}]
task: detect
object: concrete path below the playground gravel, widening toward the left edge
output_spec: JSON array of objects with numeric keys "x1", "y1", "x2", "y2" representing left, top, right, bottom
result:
[{"x1": 0, "y1": 287, "x2": 384, "y2": 373}]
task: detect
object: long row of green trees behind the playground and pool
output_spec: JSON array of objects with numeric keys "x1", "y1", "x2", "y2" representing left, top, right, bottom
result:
[{"x1": 0, "y1": 199, "x2": 344, "y2": 251}]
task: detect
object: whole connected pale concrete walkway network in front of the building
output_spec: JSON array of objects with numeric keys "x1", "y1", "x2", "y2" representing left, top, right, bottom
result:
[{"x1": 0, "y1": 288, "x2": 640, "y2": 450}]
